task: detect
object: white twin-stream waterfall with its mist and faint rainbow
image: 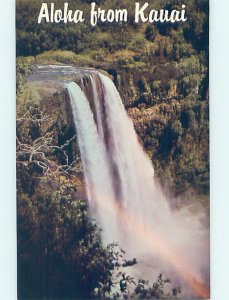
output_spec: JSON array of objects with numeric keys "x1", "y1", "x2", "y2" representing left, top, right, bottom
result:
[{"x1": 67, "y1": 73, "x2": 209, "y2": 299}]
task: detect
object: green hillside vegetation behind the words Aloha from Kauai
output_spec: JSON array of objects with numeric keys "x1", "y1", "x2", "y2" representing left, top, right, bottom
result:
[{"x1": 17, "y1": 0, "x2": 208, "y2": 58}]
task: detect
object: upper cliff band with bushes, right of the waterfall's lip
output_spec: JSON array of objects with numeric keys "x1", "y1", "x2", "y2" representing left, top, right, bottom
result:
[{"x1": 100, "y1": 57, "x2": 208, "y2": 105}]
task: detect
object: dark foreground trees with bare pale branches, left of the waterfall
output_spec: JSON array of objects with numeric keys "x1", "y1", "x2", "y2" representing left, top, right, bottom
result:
[{"x1": 17, "y1": 107, "x2": 140, "y2": 299}]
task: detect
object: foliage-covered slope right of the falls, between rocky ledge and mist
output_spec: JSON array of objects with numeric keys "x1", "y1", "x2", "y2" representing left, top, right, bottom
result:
[{"x1": 130, "y1": 98, "x2": 209, "y2": 194}]
